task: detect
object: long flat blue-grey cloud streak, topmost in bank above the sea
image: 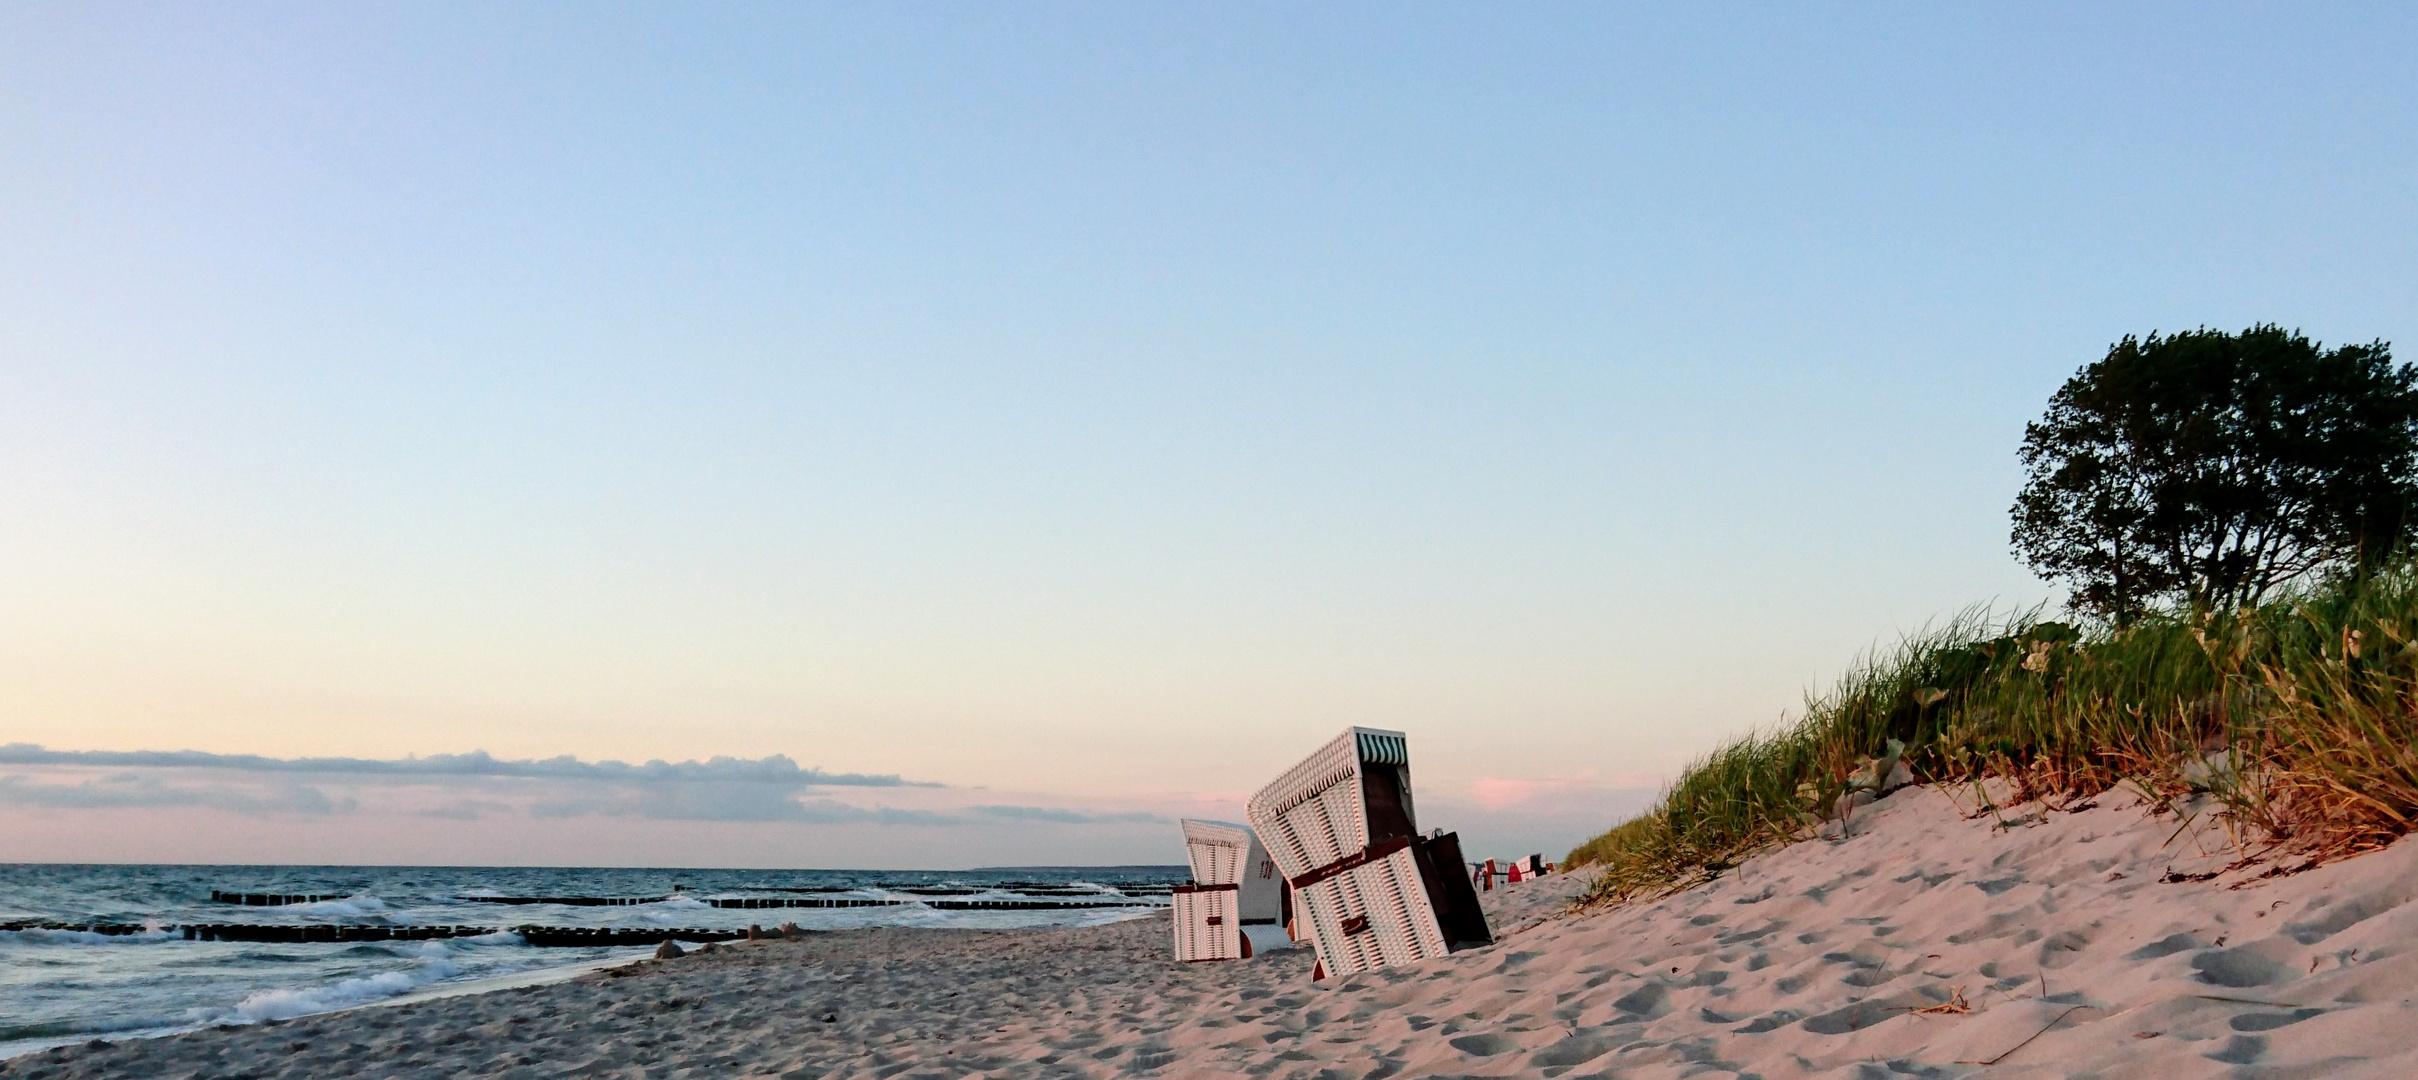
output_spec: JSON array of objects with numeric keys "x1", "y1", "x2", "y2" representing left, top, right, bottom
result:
[{"x1": 0, "y1": 742, "x2": 938, "y2": 788}]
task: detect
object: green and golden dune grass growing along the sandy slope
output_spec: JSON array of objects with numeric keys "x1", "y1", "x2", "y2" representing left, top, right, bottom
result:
[{"x1": 1567, "y1": 568, "x2": 2418, "y2": 904}]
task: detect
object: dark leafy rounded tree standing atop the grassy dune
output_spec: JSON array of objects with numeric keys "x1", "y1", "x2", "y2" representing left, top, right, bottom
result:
[{"x1": 2014, "y1": 324, "x2": 2418, "y2": 621}]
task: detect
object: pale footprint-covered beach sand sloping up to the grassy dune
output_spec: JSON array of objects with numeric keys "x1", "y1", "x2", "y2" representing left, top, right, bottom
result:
[{"x1": 0, "y1": 788, "x2": 2418, "y2": 1080}]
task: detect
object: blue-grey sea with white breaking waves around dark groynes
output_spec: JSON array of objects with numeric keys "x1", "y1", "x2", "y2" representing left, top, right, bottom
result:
[{"x1": 0, "y1": 863, "x2": 1190, "y2": 1058}]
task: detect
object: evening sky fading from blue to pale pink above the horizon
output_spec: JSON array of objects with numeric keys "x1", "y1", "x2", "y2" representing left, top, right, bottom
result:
[{"x1": 0, "y1": 2, "x2": 2418, "y2": 867}]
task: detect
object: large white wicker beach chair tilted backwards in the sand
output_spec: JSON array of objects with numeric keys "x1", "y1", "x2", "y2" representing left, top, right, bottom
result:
[{"x1": 1245, "y1": 727, "x2": 1494, "y2": 976}]
